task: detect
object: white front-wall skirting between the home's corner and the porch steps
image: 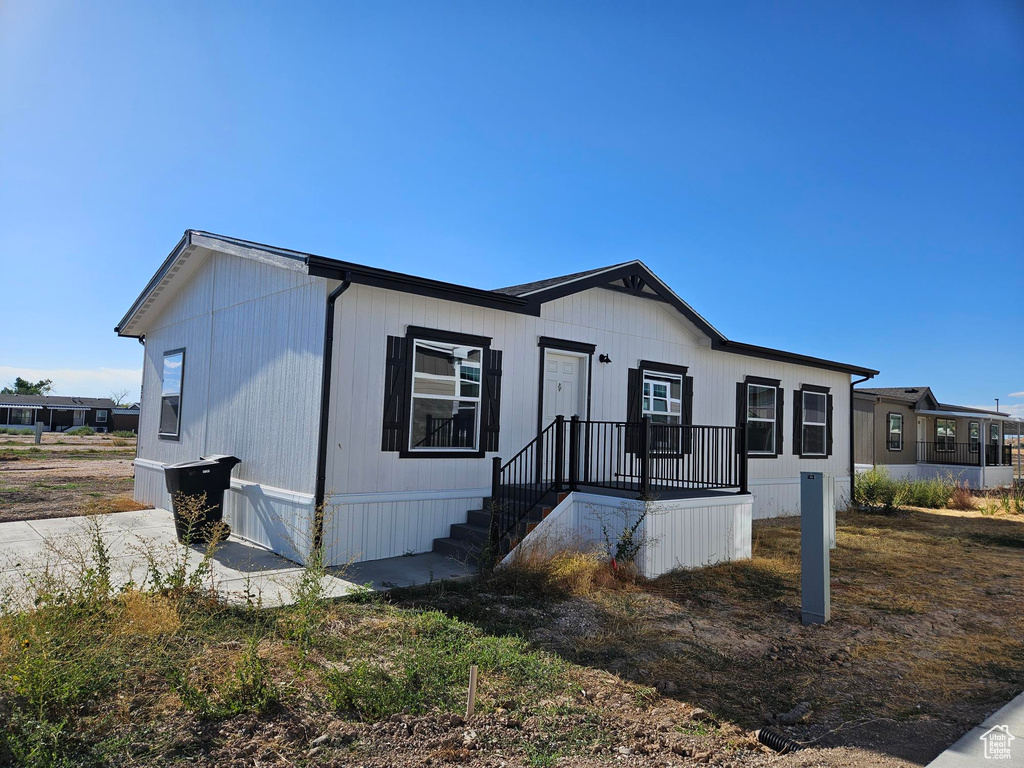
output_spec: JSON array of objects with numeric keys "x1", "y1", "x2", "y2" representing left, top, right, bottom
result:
[{"x1": 324, "y1": 488, "x2": 490, "y2": 565}]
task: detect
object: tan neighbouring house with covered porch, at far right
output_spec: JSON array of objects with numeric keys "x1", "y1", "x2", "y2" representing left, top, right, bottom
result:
[{"x1": 853, "y1": 387, "x2": 1020, "y2": 488}]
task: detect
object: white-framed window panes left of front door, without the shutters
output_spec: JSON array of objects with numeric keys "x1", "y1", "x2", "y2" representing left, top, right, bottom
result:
[{"x1": 409, "y1": 339, "x2": 483, "y2": 452}]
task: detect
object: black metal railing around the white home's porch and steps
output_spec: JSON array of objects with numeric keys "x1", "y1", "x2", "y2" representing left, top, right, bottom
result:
[{"x1": 492, "y1": 416, "x2": 748, "y2": 549}]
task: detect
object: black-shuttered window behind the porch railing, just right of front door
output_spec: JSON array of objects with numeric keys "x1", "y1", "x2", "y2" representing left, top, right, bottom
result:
[{"x1": 626, "y1": 360, "x2": 693, "y2": 455}]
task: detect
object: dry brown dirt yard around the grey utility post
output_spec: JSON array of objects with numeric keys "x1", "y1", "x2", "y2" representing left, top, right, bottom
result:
[{"x1": 396, "y1": 511, "x2": 1024, "y2": 766}]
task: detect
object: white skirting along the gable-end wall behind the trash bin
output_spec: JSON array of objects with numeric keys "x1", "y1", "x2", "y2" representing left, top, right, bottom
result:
[{"x1": 135, "y1": 459, "x2": 315, "y2": 563}]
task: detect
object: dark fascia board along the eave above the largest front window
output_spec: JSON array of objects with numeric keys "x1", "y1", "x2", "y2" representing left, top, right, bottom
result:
[{"x1": 305, "y1": 255, "x2": 541, "y2": 315}]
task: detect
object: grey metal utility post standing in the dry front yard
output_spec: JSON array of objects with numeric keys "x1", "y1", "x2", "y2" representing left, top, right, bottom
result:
[{"x1": 800, "y1": 472, "x2": 836, "y2": 624}]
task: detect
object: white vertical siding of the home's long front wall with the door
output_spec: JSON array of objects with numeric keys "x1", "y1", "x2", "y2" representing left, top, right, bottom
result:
[{"x1": 325, "y1": 285, "x2": 850, "y2": 562}]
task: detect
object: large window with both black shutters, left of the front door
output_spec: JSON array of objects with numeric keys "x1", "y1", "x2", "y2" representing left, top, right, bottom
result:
[{"x1": 381, "y1": 327, "x2": 502, "y2": 459}]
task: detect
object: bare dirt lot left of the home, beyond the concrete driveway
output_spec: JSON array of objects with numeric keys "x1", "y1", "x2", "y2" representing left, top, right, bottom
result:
[{"x1": 0, "y1": 433, "x2": 144, "y2": 522}]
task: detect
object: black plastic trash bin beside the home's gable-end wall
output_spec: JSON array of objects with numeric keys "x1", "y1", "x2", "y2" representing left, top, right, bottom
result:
[{"x1": 164, "y1": 455, "x2": 242, "y2": 543}]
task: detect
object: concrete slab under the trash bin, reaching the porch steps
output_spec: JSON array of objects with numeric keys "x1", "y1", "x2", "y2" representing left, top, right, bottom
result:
[{"x1": 0, "y1": 509, "x2": 471, "y2": 606}]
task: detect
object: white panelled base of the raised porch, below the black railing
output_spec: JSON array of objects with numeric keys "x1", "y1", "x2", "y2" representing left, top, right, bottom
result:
[{"x1": 505, "y1": 493, "x2": 753, "y2": 579}]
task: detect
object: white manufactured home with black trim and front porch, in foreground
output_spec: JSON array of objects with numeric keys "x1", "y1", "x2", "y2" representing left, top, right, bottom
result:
[{"x1": 116, "y1": 230, "x2": 877, "y2": 570}]
